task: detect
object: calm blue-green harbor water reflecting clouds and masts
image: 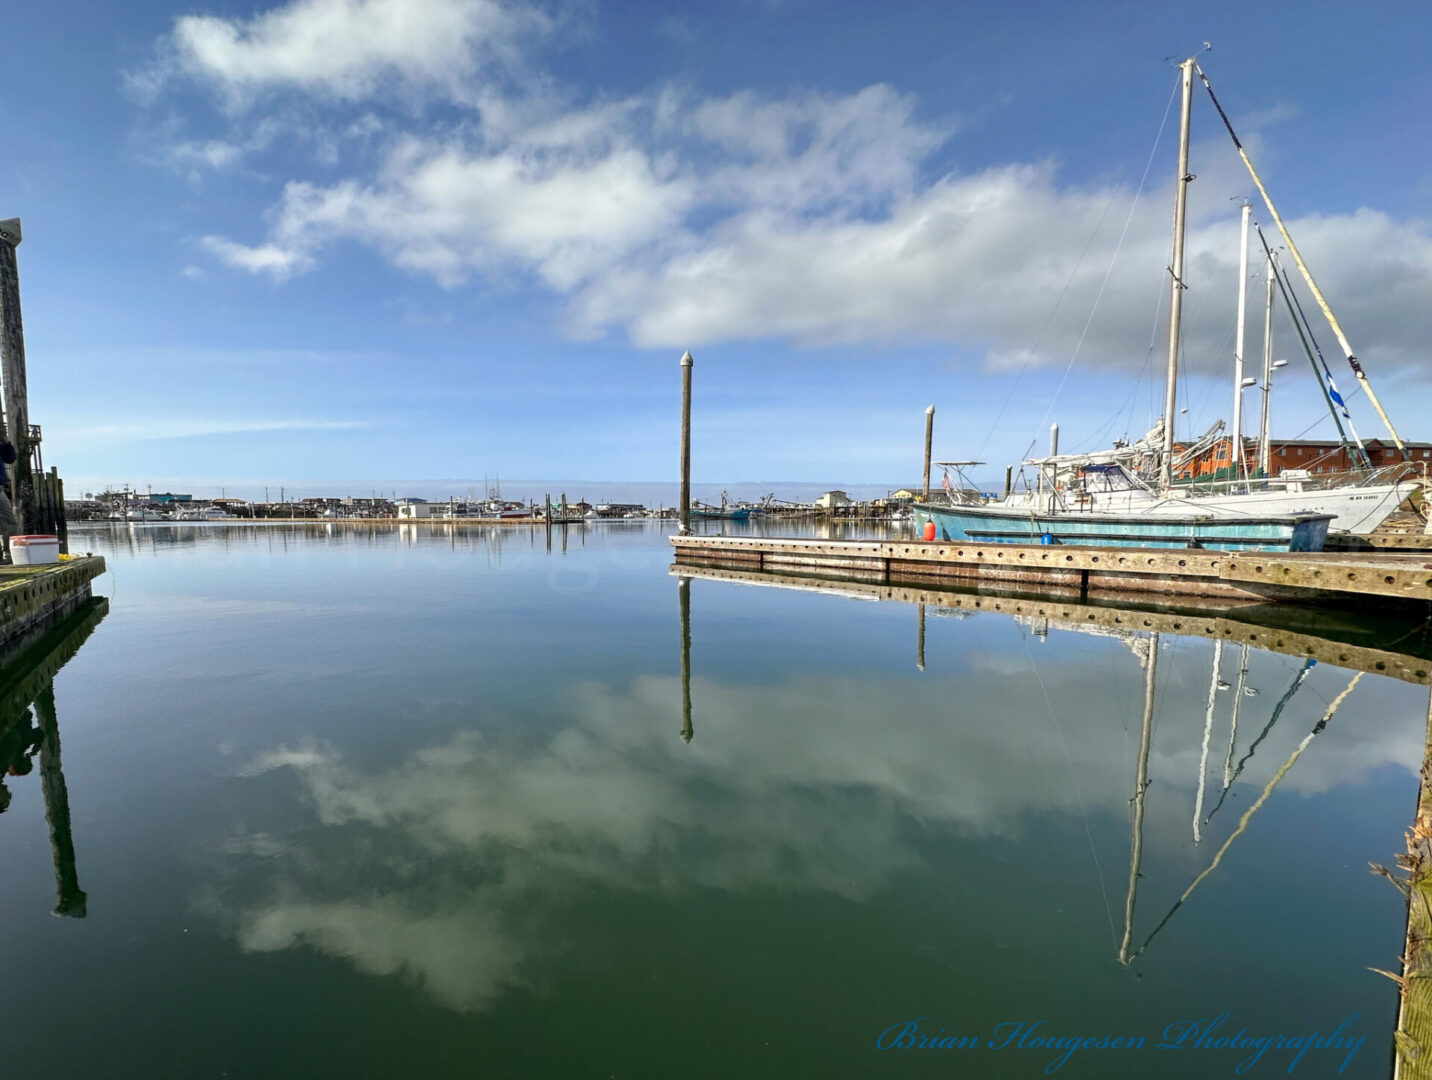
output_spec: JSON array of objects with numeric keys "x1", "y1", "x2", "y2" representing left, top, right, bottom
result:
[{"x1": 0, "y1": 523, "x2": 1428, "y2": 1077}]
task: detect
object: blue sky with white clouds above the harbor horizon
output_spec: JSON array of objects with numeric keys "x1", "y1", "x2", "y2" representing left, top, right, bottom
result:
[{"x1": 0, "y1": 0, "x2": 1432, "y2": 496}]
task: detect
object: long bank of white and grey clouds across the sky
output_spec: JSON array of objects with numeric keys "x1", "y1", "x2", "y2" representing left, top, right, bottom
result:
[{"x1": 142, "y1": 0, "x2": 1432, "y2": 371}]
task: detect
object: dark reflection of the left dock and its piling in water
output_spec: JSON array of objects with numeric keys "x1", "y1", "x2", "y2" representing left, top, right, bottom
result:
[{"x1": 0, "y1": 597, "x2": 109, "y2": 918}]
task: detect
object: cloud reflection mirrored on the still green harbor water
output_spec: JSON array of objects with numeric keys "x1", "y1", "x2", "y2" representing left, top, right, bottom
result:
[{"x1": 203, "y1": 621, "x2": 1421, "y2": 1011}]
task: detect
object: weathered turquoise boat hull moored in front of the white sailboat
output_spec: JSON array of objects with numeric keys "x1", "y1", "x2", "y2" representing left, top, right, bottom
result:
[{"x1": 915, "y1": 503, "x2": 1333, "y2": 551}]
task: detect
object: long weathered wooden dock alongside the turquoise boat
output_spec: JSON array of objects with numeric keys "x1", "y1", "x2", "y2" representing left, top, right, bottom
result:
[{"x1": 670, "y1": 536, "x2": 1432, "y2": 603}]
